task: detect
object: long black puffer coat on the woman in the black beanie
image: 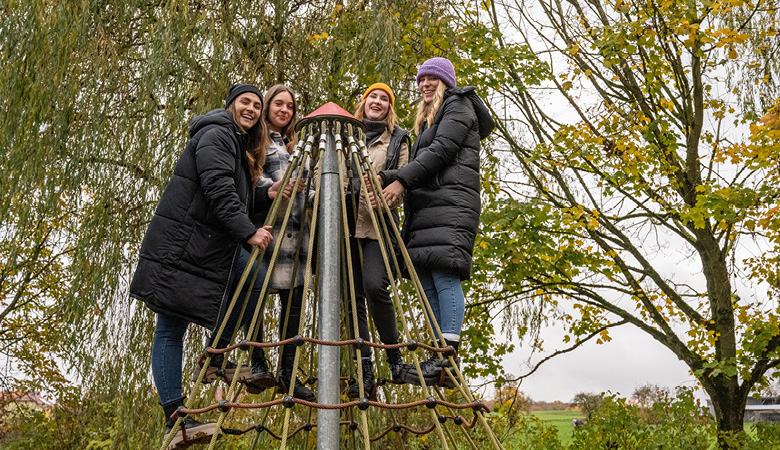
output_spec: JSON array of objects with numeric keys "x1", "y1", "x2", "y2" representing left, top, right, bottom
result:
[{"x1": 130, "y1": 109, "x2": 271, "y2": 329}]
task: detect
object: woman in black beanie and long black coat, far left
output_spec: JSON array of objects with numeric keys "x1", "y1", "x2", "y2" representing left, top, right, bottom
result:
[{"x1": 130, "y1": 84, "x2": 278, "y2": 448}]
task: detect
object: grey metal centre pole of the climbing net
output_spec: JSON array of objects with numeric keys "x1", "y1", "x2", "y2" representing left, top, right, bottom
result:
[{"x1": 317, "y1": 123, "x2": 341, "y2": 450}]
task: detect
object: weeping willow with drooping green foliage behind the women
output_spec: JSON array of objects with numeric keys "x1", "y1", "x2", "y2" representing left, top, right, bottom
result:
[{"x1": 0, "y1": 0, "x2": 447, "y2": 448}]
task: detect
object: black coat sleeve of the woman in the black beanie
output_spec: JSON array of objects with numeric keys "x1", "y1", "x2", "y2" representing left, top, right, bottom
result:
[{"x1": 195, "y1": 127, "x2": 257, "y2": 242}]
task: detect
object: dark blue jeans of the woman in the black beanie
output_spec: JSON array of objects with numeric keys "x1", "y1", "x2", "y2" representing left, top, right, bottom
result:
[{"x1": 152, "y1": 248, "x2": 265, "y2": 406}]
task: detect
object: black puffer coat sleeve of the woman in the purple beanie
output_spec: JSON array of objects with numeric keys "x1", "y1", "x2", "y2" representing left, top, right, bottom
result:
[{"x1": 396, "y1": 95, "x2": 477, "y2": 189}]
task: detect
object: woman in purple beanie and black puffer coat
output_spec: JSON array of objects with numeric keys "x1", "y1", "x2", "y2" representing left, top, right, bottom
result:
[{"x1": 380, "y1": 57, "x2": 495, "y2": 387}]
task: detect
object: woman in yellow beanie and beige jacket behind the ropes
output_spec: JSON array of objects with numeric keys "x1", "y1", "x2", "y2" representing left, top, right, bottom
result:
[{"x1": 347, "y1": 83, "x2": 411, "y2": 398}]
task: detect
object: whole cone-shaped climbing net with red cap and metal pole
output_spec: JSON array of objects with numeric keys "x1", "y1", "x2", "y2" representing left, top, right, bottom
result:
[{"x1": 160, "y1": 103, "x2": 503, "y2": 450}]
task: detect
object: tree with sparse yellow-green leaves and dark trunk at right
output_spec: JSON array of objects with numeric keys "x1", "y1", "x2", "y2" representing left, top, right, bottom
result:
[{"x1": 450, "y1": 0, "x2": 780, "y2": 447}]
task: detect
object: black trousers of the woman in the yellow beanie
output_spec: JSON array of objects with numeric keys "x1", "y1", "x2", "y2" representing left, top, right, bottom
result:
[{"x1": 347, "y1": 238, "x2": 400, "y2": 357}]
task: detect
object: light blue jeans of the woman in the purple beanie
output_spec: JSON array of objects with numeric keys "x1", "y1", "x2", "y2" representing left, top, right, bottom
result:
[{"x1": 415, "y1": 267, "x2": 466, "y2": 341}]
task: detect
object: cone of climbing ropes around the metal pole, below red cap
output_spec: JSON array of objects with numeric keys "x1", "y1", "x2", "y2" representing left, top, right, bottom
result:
[{"x1": 160, "y1": 109, "x2": 503, "y2": 450}]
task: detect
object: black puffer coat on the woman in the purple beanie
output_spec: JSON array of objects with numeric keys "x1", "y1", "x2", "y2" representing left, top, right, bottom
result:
[{"x1": 382, "y1": 87, "x2": 495, "y2": 280}]
